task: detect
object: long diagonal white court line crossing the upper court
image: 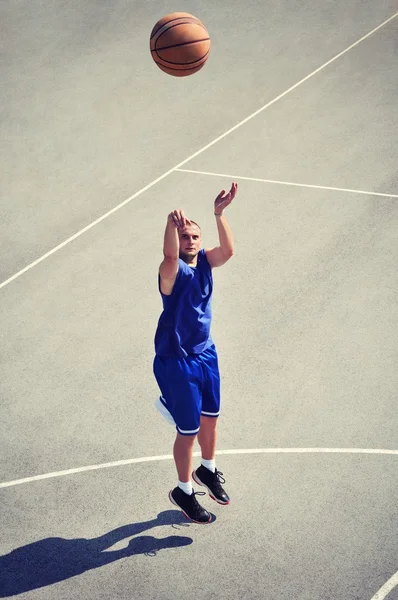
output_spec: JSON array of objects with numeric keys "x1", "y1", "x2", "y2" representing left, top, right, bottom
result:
[{"x1": 0, "y1": 12, "x2": 398, "y2": 289}]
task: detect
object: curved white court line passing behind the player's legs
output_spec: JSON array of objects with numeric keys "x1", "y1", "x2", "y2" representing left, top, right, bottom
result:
[{"x1": 0, "y1": 448, "x2": 398, "y2": 488}]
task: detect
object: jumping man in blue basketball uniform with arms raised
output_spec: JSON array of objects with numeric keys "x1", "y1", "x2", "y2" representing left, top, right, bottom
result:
[{"x1": 153, "y1": 183, "x2": 238, "y2": 523}]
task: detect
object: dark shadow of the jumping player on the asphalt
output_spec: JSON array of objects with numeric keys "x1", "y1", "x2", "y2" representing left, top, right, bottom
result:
[{"x1": 0, "y1": 510, "x2": 202, "y2": 598}]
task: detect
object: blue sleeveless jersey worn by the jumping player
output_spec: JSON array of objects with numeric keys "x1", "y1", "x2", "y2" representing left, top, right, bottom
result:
[{"x1": 155, "y1": 249, "x2": 213, "y2": 357}]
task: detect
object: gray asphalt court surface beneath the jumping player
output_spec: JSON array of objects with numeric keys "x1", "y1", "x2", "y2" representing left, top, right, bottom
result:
[{"x1": 0, "y1": 0, "x2": 398, "y2": 600}]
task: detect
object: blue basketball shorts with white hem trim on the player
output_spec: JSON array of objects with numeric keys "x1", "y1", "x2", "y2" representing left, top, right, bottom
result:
[{"x1": 153, "y1": 345, "x2": 220, "y2": 435}]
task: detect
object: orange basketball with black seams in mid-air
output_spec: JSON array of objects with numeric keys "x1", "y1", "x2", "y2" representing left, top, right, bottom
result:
[{"x1": 150, "y1": 12, "x2": 210, "y2": 77}]
